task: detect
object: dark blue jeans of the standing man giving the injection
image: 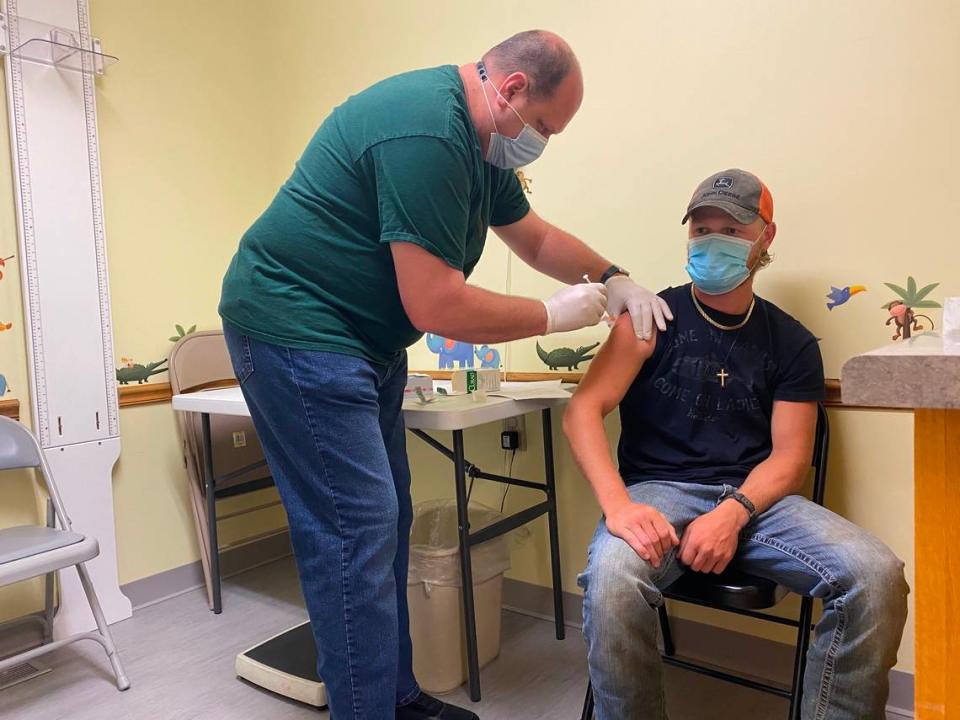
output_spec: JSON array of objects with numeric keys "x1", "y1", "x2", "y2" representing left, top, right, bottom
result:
[{"x1": 224, "y1": 323, "x2": 420, "y2": 720}]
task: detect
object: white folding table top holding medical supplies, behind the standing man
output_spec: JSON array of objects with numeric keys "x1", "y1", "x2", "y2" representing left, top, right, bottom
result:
[{"x1": 173, "y1": 383, "x2": 566, "y2": 430}]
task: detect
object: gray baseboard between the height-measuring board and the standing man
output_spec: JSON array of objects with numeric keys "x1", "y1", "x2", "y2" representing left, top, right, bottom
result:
[{"x1": 120, "y1": 528, "x2": 293, "y2": 610}]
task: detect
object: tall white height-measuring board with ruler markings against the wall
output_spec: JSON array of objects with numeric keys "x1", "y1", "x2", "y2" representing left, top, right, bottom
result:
[{"x1": 0, "y1": 0, "x2": 131, "y2": 634}]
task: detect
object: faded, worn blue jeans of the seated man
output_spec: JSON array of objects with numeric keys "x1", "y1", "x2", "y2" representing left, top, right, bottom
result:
[{"x1": 578, "y1": 482, "x2": 908, "y2": 720}]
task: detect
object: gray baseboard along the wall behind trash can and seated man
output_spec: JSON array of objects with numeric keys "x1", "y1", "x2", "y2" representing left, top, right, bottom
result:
[{"x1": 503, "y1": 578, "x2": 914, "y2": 720}]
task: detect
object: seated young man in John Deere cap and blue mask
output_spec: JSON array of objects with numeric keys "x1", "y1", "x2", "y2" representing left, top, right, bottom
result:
[{"x1": 564, "y1": 170, "x2": 907, "y2": 720}]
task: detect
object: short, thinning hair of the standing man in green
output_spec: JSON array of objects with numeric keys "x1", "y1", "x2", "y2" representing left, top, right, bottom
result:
[{"x1": 483, "y1": 30, "x2": 576, "y2": 99}]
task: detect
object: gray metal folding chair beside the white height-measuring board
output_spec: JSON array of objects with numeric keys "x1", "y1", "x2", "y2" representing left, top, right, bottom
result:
[{"x1": 0, "y1": 417, "x2": 130, "y2": 690}]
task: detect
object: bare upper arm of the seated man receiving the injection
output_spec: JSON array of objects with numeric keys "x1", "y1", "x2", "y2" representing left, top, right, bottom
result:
[{"x1": 571, "y1": 313, "x2": 657, "y2": 415}]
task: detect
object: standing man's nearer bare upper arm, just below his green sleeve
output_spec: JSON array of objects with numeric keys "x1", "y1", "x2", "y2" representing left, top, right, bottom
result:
[{"x1": 390, "y1": 242, "x2": 466, "y2": 332}]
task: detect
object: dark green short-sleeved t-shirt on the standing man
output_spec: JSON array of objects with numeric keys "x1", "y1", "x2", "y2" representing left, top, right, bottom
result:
[{"x1": 219, "y1": 65, "x2": 529, "y2": 363}]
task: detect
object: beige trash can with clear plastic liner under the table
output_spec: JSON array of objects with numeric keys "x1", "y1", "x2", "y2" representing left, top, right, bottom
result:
[{"x1": 407, "y1": 500, "x2": 529, "y2": 693}]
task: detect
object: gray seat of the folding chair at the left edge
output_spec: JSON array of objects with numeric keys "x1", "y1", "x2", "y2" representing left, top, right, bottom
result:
[{"x1": 0, "y1": 525, "x2": 100, "y2": 585}]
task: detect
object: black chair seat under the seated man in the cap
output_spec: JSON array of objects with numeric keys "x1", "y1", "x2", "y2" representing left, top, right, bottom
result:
[{"x1": 663, "y1": 568, "x2": 788, "y2": 610}]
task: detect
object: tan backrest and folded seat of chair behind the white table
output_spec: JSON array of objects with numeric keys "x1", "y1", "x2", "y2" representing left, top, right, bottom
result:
[{"x1": 169, "y1": 330, "x2": 269, "y2": 490}]
